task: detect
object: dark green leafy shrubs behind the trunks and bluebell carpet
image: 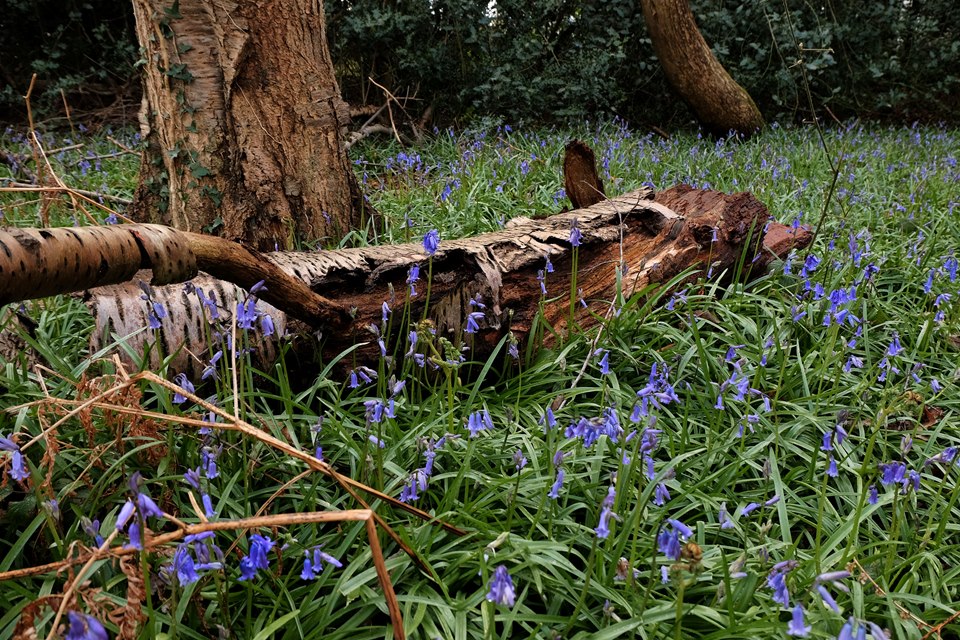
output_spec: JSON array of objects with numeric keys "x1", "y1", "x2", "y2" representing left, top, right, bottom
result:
[{"x1": 0, "y1": 0, "x2": 960, "y2": 124}]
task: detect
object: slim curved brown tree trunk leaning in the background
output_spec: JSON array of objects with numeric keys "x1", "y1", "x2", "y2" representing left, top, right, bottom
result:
[{"x1": 640, "y1": 0, "x2": 763, "y2": 135}]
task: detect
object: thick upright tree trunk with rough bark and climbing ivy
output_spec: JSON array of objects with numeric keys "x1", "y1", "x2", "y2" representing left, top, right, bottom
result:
[{"x1": 131, "y1": 0, "x2": 368, "y2": 250}]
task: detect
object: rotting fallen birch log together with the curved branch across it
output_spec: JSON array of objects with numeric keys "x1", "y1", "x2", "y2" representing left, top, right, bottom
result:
[{"x1": 0, "y1": 185, "x2": 811, "y2": 375}]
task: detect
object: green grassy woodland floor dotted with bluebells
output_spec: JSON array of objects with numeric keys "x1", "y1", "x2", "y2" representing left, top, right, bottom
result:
[{"x1": 0, "y1": 123, "x2": 960, "y2": 640}]
